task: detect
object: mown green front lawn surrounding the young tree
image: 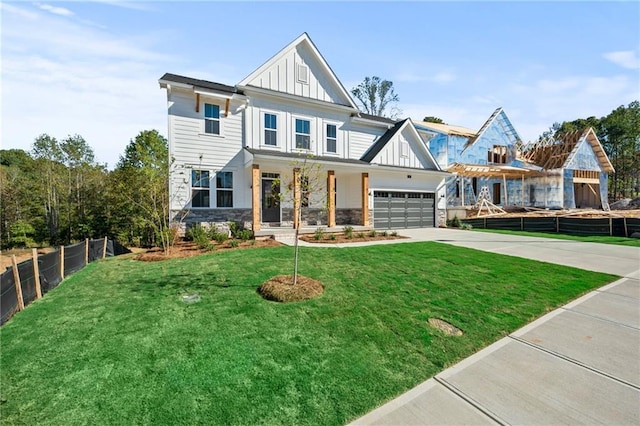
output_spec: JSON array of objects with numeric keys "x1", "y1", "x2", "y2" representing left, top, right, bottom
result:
[{"x1": 0, "y1": 243, "x2": 615, "y2": 425}]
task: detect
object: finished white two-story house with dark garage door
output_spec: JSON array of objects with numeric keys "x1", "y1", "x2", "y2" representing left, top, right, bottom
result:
[{"x1": 159, "y1": 33, "x2": 448, "y2": 231}]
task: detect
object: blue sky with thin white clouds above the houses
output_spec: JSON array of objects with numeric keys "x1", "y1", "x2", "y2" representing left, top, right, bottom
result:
[{"x1": 0, "y1": 0, "x2": 640, "y2": 168}]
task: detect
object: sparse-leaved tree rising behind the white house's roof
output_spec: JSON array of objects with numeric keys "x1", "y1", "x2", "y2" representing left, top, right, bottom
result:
[{"x1": 351, "y1": 76, "x2": 400, "y2": 119}]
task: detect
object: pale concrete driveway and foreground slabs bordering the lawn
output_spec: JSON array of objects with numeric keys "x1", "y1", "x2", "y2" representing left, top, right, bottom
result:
[{"x1": 353, "y1": 229, "x2": 640, "y2": 425}]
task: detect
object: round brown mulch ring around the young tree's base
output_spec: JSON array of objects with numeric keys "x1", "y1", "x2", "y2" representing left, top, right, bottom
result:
[{"x1": 258, "y1": 275, "x2": 324, "y2": 303}]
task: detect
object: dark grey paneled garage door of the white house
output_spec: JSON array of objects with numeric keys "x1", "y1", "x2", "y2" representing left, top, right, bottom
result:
[{"x1": 373, "y1": 191, "x2": 435, "y2": 229}]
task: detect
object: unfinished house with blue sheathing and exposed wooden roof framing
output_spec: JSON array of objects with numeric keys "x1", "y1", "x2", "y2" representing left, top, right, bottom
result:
[{"x1": 416, "y1": 108, "x2": 614, "y2": 217}]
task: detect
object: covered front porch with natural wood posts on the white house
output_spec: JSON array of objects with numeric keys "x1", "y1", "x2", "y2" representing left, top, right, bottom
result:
[{"x1": 245, "y1": 150, "x2": 372, "y2": 231}]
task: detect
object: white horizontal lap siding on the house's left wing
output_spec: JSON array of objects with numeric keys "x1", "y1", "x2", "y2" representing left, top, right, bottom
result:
[{"x1": 168, "y1": 89, "x2": 250, "y2": 210}]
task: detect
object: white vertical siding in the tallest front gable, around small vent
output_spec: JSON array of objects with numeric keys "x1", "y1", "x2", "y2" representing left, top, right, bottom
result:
[{"x1": 248, "y1": 44, "x2": 346, "y2": 105}]
